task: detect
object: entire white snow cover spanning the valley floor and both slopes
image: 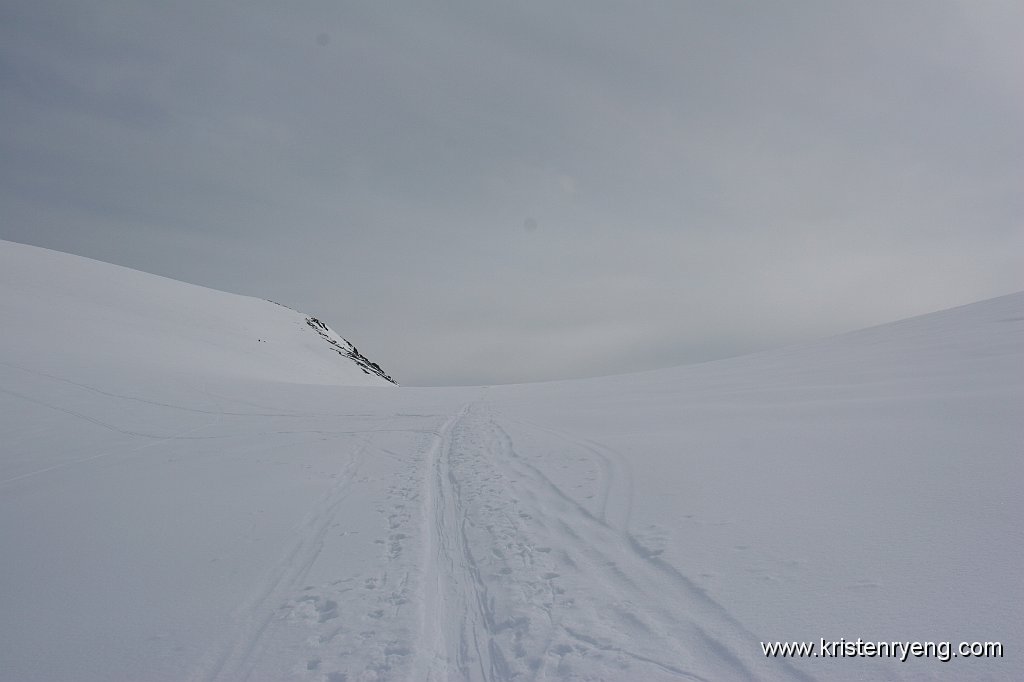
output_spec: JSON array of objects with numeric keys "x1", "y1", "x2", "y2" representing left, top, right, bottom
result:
[{"x1": 0, "y1": 236, "x2": 1024, "y2": 682}]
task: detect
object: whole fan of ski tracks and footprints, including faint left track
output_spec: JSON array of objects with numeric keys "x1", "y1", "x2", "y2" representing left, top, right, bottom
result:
[{"x1": 201, "y1": 401, "x2": 810, "y2": 682}]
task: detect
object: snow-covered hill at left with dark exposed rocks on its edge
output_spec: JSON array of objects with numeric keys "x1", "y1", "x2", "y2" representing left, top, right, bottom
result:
[{"x1": 0, "y1": 241, "x2": 395, "y2": 386}]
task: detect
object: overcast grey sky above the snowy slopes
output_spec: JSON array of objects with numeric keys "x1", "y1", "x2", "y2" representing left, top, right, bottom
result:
[{"x1": 0, "y1": 0, "x2": 1024, "y2": 384}]
